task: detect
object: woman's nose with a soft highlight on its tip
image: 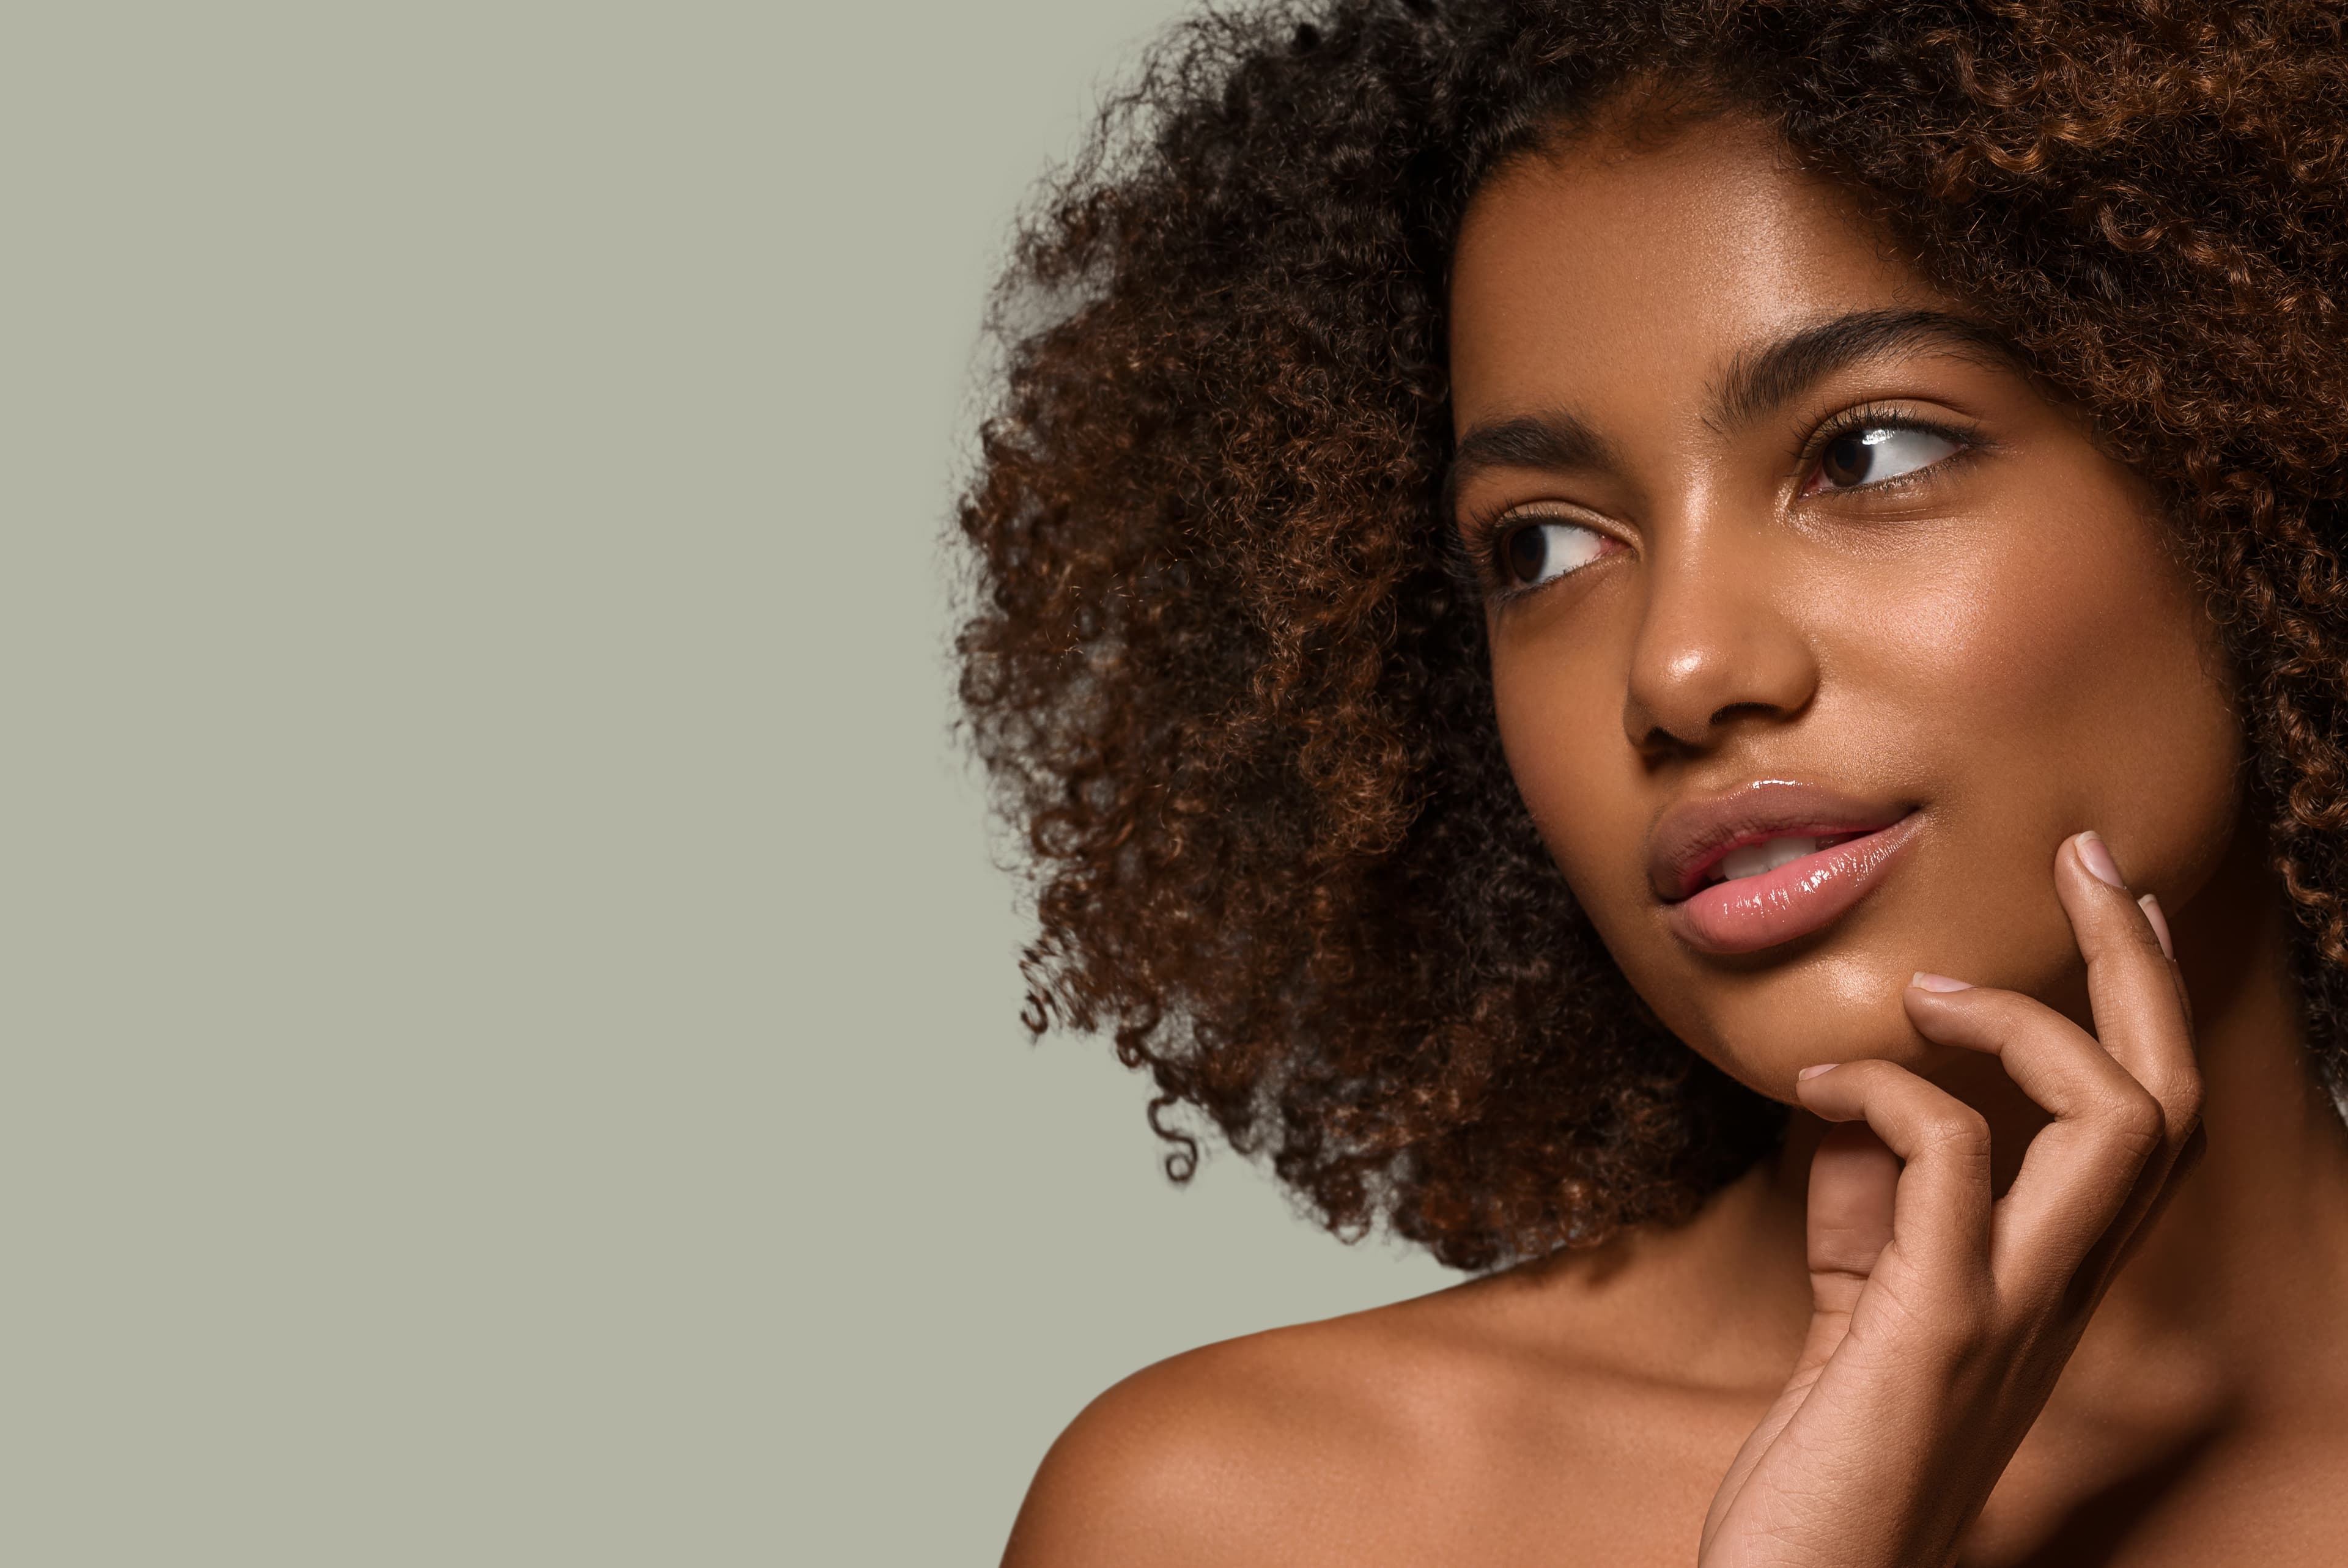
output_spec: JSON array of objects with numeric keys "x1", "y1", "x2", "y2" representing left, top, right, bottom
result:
[{"x1": 1622, "y1": 523, "x2": 1817, "y2": 756}]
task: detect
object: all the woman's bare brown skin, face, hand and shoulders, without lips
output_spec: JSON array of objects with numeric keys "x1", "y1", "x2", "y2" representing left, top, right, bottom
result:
[{"x1": 1005, "y1": 117, "x2": 2348, "y2": 1568}]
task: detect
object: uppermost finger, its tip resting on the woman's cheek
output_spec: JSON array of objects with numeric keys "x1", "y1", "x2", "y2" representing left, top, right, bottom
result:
[{"x1": 2054, "y1": 833, "x2": 2200, "y2": 1146}]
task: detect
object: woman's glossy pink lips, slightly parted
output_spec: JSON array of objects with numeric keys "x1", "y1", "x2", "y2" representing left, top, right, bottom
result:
[{"x1": 1648, "y1": 779, "x2": 1923, "y2": 953}]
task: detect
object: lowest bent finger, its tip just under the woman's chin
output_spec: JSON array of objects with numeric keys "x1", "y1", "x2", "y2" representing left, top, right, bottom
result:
[{"x1": 1794, "y1": 1061, "x2": 1988, "y2": 1268}]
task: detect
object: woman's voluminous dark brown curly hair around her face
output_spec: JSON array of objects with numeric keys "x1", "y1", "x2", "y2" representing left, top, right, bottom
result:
[{"x1": 958, "y1": 0, "x2": 2348, "y2": 1270}]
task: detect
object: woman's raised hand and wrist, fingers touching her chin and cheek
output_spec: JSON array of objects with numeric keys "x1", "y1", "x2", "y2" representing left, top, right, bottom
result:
[{"x1": 1700, "y1": 833, "x2": 2200, "y2": 1568}]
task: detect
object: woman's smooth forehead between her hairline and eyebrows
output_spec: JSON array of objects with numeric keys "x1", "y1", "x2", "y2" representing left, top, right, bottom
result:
[{"x1": 1451, "y1": 117, "x2": 1949, "y2": 427}]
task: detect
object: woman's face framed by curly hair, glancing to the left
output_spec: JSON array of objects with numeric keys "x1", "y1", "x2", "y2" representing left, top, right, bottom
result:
[{"x1": 1451, "y1": 120, "x2": 2242, "y2": 1099}]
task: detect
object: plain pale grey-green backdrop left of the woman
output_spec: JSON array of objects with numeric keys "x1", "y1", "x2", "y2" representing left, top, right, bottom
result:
[{"x1": 0, "y1": 0, "x2": 1449, "y2": 1568}]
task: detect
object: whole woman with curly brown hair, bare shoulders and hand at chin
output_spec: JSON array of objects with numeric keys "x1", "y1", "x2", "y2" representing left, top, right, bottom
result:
[{"x1": 962, "y1": 0, "x2": 2348, "y2": 1568}]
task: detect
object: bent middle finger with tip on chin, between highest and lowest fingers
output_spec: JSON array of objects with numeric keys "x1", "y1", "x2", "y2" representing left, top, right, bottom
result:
[{"x1": 1902, "y1": 974, "x2": 2165, "y2": 1284}]
